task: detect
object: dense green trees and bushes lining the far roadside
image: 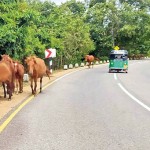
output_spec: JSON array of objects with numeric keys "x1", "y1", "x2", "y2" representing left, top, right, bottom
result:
[{"x1": 0, "y1": 0, "x2": 150, "y2": 69}]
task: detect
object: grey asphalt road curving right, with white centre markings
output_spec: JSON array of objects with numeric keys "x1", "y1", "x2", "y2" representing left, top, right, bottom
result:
[{"x1": 0, "y1": 60, "x2": 150, "y2": 150}]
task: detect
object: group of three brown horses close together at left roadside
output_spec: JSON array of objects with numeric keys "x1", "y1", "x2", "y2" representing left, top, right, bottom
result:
[{"x1": 0, "y1": 54, "x2": 50, "y2": 100}]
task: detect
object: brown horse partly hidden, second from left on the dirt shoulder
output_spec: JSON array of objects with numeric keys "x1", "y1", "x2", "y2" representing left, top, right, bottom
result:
[{"x1": 13, "y1": 61, "x2": 24, "y2": 94}]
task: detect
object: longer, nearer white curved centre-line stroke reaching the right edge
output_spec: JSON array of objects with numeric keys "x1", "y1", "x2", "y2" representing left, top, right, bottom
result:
[{"x1": 118, "y1": 83, "x2": 150, "y2": 111}]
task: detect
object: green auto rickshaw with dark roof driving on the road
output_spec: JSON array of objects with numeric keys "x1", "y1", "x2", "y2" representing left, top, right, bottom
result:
[{"x1": 109, "y1": 50, "x2": 128, "y2": 73}]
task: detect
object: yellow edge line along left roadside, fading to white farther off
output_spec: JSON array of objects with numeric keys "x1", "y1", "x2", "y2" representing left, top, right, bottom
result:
[{"x1": 0, "y1": 69, "x2": 83, "y2": 133}]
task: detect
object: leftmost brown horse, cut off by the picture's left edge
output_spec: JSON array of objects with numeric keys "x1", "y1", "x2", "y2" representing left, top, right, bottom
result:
[{"x1": 0, "y1": 55, "x2": 15, "y2": 100}]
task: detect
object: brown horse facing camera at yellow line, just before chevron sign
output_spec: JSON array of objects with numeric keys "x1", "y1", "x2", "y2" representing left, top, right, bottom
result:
[{"x1": 25, "y1": 56, "x2": 47, "y2": 95}]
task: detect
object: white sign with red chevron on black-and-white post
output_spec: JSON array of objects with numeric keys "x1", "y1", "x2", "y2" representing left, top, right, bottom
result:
[{"x1": 45, "y1": 48, "x2": 56, "y2": 73}]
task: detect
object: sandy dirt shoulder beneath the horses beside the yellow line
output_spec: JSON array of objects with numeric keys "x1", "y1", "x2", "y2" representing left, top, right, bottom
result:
[{"x1": 0, "y1": 66, "x2": 87, "y2": 120}]
